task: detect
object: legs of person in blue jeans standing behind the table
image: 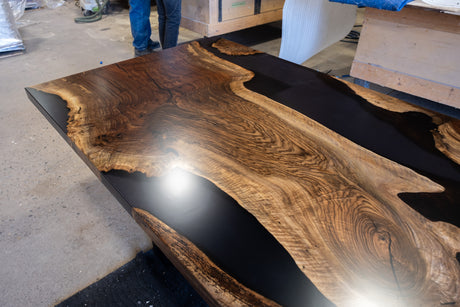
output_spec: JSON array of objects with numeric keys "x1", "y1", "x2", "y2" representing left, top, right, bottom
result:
[{"x1": 129, "y1": 0, "x2": 181, "y2": 56}]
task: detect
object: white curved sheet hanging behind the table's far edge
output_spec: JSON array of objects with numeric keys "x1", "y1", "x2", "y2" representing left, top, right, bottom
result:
[{"x1": 280, "y1": 0, "x2": 357, "y2": 64}]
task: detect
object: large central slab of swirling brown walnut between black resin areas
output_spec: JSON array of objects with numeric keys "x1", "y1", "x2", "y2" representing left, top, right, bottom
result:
[{"x1": 35, "y1": 43, "x2": 460, "y2": 306}]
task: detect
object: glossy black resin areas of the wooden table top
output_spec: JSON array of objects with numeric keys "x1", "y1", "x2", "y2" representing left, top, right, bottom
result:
[{"x1": 26, "y1": 39, "x2": 460, "y2": 306}]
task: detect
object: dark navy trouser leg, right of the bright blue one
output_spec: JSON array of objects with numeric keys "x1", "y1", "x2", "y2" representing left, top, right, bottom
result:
[{"x1": 156, "y1": 0, "x2": 182, "y2": 49}]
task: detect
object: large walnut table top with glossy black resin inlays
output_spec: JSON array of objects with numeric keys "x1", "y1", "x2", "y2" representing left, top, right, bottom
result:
[{"x1": 26, "y1": 39, "x2": 460, "y2": 306}]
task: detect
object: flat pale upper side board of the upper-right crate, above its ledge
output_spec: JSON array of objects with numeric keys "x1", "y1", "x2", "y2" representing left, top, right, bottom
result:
[{"x1": 355, "y1": 9, "x2": 460, "y2": 88}]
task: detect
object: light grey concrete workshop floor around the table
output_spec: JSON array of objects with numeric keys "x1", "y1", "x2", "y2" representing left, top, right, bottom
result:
[{"x1": 0, "y1": 1, "x2": 362, "y2": 306}]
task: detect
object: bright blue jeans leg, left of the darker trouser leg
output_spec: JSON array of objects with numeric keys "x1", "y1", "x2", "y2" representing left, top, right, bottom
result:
[{"x1": 129, "y1": 0, "x2": 152, "y2": 50}]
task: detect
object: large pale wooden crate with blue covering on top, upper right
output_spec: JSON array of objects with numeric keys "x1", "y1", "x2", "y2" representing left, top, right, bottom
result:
[{"x1": 350, "y1": 7, "x2": 460, "y2": 108}]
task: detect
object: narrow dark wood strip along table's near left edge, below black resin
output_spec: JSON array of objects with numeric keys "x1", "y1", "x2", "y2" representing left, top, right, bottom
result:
[{"x1": 132, "y1": 208, "x2": 279, "y2": 307}]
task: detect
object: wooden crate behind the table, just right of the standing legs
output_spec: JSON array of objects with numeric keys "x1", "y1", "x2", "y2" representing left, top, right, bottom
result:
[{"x1": 181, "y1": 0, "x2": 284, "y2": 37}]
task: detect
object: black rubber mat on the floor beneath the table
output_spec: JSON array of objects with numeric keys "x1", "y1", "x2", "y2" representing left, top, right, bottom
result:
[{"x1": 57, "y1": 247, "x2": 207, "y2": 307}]
